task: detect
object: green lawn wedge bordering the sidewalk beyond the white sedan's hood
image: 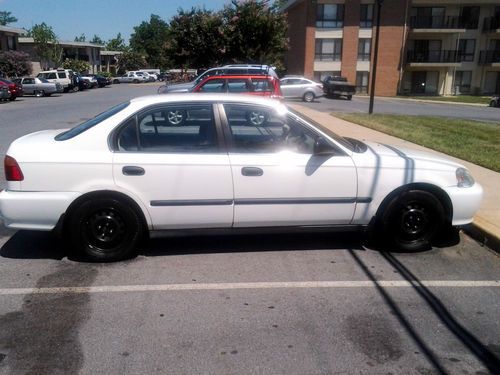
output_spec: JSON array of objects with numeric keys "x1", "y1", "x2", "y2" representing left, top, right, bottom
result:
[{"x1": 335, "y1": 113, "x2": 500, "y2": 172}]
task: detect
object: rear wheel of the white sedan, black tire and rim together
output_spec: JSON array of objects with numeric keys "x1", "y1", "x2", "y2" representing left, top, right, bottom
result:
[{"x1": 68, "y1": 197, "x2": 144, "y2": 262}]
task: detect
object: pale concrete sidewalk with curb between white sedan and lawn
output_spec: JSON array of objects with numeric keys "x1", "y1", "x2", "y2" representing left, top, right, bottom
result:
[{"x1": 287, "y1": 103, "x2": 500, "y2": 251}]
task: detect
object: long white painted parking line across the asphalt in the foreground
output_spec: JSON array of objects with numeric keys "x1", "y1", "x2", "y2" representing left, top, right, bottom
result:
[{"x1": 0, "y1": 280, "x2": 500, "y2": 296}]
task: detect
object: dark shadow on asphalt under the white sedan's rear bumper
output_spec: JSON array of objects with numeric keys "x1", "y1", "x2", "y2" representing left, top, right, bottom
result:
[{"x1": 0, "y1": 230, "x2": 67, "y2": 260}]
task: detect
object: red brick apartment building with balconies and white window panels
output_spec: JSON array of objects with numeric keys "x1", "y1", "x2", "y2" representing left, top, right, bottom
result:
[{"x1": 284, "y1": 0, "x2": 500, "y2": 96}]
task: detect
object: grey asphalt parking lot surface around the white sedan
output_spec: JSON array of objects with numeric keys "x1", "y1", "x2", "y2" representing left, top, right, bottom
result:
[{"x1": 0, "y1": 84, "x2": 500, "y2": 375}]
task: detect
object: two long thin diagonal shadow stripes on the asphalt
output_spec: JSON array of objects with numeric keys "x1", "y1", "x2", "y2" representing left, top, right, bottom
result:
[{"x1": 349, "y1": 249, "x2": 500, "y2": 374}]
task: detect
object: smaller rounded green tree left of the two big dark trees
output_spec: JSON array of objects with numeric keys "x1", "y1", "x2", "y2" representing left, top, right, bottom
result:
[{"x1": 129, "y1": 14, "x2": 168, "y2": 68}]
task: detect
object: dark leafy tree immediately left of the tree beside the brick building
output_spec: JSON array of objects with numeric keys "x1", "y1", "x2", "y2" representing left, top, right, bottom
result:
[{"x1": 166, "y1": 8, "x2": 225, "y2": 68}]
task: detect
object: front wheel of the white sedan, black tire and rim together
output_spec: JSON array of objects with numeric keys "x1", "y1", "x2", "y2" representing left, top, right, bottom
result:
[{"x1": 381, "y1": 190, "x2": 445, "y2": 252}]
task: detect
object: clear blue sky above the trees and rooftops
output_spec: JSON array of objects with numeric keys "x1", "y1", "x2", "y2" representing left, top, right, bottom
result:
[{"x1": 0, "y1": 0, "x2": 230, "y2": 42}]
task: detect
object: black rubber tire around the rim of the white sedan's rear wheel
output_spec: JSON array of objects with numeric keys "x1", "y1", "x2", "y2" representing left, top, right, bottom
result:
[{"x1": 68, "y1": 198, "x2": 143, "y2": 262}]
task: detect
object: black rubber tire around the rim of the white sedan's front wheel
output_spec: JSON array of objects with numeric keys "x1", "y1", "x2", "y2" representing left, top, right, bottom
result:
[{"x1": 381, "y1": 190, "x2": 445, "y2": 252}]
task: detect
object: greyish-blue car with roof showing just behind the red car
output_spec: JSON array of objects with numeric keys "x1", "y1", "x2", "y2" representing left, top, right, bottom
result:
[{"x1": 158, "y1": 64, "x2": 278, "y2": 94}]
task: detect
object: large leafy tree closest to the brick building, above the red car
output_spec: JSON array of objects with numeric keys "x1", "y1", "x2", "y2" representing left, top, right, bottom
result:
[{"x1": 222, "y1": 0, "x2": 288, "y2": 68}]
